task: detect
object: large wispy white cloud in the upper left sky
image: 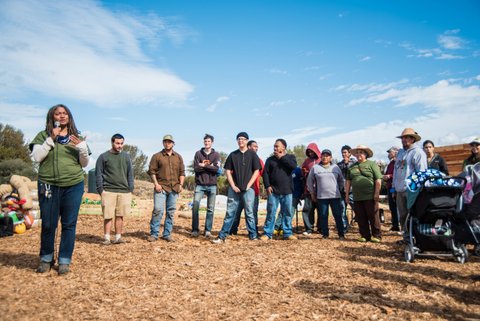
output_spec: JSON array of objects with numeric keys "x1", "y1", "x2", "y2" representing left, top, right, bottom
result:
[{"x1": 0, "y1": 0, "x2": 193, "y2": 107}]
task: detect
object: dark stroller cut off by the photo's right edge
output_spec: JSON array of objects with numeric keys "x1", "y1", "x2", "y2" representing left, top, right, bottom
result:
[{"x1": 454, "y1": 163, "x2": 480, "y2": 256}]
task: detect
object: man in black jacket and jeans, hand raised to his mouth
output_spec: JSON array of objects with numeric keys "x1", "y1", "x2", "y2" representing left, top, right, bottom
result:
[{"x1": 261, "y1": 138, "x2": 297, "y2": 241}]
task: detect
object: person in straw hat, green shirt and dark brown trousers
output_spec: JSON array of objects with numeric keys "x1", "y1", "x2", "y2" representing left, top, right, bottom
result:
[{"x1": 345, "y1": 145, "x2": 383, "y2": 243}]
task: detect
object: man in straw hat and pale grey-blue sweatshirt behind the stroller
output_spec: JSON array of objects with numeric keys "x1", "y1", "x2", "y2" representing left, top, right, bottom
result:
[{"x1": 393, "y1": 128, "x2": 428, "y2": 229}]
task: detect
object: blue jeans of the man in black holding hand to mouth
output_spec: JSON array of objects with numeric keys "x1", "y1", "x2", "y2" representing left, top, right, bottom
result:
[{"x1": 263, "y1": 193, "x2": 292, "y2": 238}]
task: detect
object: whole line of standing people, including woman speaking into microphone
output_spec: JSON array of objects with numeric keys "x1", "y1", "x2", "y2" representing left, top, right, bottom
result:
[{"x1": 29, "y1": 104, "x2": 480, "y2": 275}]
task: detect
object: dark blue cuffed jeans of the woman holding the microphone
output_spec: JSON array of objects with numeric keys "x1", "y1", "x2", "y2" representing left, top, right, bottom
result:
[{"x1": 38, "y1": 181, "x2": 84, "y2": 264}]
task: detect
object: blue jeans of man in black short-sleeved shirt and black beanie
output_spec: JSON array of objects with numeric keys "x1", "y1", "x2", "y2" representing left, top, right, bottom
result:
[{"x1": 218, "y1": 187, "x2": 257, "y2": 240}]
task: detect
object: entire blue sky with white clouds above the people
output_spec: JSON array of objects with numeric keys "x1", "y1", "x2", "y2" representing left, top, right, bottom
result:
[{"x1": 0, "y1": 0, "x2": 480, "y2": 167}]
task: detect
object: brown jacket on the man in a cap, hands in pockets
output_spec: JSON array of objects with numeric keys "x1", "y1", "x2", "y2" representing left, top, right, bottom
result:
[{"x1": 148, "y1": 150, "x2": 185, "y2": 193}]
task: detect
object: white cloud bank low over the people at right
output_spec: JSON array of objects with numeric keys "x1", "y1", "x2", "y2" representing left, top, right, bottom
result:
[{"x1": 278, "y1": 80, "x2": 480, "y2": 159}]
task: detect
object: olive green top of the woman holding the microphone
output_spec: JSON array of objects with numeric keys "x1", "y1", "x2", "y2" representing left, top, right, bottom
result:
[{"x1": 30, "y1": 131, "x2": 85, "y2": 187}]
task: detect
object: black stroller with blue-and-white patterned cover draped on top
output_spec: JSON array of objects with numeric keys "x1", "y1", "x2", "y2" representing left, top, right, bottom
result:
[{"x1": 404, "y1": 169, "x2": 468, "y2": 264}]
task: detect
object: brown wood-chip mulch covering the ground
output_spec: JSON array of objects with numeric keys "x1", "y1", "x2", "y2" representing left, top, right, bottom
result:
[{"x1": 0, "y1": 198, "x2": 480, "y2": 320}]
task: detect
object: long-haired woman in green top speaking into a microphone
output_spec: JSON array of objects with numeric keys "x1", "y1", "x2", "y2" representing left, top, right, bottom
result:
[{"x1": 29, "y1": 104, "x2": 90, "y2": 275}]
